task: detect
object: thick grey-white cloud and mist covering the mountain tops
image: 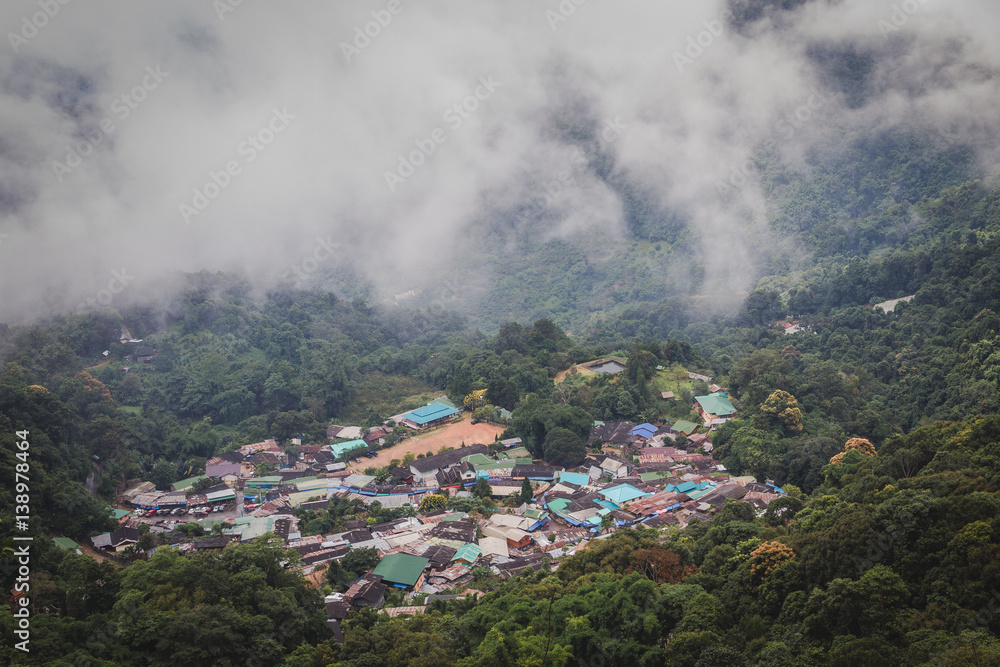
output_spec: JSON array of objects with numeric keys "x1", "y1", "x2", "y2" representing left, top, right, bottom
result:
[{"x1": 0, "y1": 0, "x2": 1000, "y2": 321}]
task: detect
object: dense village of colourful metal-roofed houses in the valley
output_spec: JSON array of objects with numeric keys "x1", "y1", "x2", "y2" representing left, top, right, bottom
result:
[{"x1": 74, "y1": 369, "x2": 784, "y2": 638}]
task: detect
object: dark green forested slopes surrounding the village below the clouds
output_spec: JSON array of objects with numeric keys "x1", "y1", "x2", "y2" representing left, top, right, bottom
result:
[{"x1": 0, "y1": 104, "x2": 1000, "y2": 665}]
